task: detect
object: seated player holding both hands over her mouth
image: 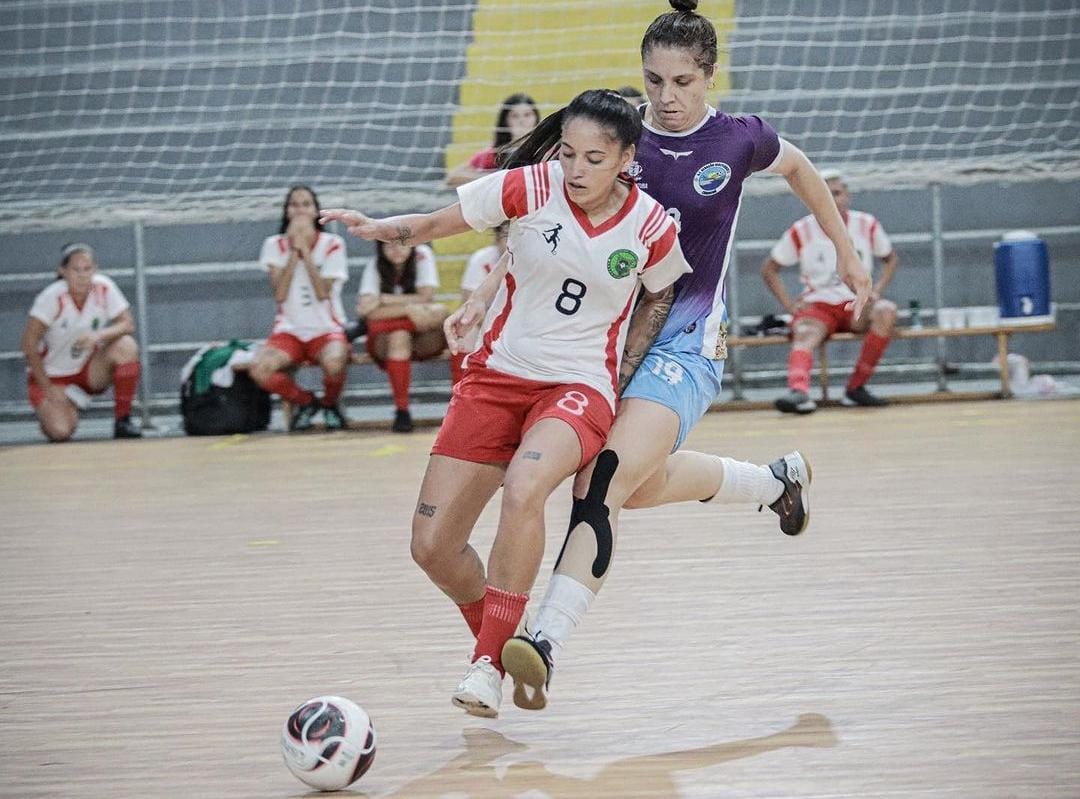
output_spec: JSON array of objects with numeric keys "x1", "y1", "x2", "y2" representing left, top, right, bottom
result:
[{"x1": 248, "y1": 186, "x2": 349, "y2": 431}]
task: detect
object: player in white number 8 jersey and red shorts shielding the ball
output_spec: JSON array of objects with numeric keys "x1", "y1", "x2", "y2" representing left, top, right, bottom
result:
[{"x1": 323, "y1": 90, "x2": 689, "y2": 716}]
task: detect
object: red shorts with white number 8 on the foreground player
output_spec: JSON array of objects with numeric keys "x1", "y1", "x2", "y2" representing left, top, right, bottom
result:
[{"x1": 431, "y1": 366, "x2": 615, "y2": 469}]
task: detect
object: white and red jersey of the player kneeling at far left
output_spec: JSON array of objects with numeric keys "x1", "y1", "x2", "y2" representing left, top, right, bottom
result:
[{"x1": 30, "y1": 274, "x2": 131, "y2": 377}]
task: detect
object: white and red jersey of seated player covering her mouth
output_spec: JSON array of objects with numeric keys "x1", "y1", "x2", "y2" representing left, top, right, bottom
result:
[{"x1": 259, "y1": 231, "x2": 349, "y2": 341}]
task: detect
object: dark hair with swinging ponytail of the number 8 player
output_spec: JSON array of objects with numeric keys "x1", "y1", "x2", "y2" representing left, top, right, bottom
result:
[{"x1": 503, "y1": 89, "x2": 642, "y2": 170}]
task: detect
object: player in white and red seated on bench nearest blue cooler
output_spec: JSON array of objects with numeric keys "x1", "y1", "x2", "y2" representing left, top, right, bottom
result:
[{"x1": 761, "y1": 170, "x2": 900, "y2": 414}]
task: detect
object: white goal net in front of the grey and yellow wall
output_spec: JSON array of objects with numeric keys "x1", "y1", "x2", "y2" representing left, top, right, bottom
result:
[{"x1": 0, "y1": 0, "x2": 1080, "y2": 231}]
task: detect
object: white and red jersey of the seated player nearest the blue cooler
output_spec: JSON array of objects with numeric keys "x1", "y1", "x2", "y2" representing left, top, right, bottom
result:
[{"x1": 769, "y1": 211, "x2": 892, "y2": 304}]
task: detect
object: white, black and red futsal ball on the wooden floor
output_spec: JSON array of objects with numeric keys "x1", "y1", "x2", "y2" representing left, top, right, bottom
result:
[{"x1": 281, "y1": 696, "x2": 375, "y2": 790}]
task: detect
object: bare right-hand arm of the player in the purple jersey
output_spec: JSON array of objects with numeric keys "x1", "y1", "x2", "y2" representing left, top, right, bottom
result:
[{"x1": 770, "y1": 140, "x2": 873, "y2": 319}]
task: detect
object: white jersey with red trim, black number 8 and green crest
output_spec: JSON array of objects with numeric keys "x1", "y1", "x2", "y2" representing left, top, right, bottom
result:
[{"x1": 458, "y1": 161, "x2": 690, "y2": 408}]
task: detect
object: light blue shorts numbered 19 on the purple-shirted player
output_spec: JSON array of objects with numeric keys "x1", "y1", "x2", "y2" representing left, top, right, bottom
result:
[{"x1": 622, "y1": 347, "x2": 724, "y2": 452}]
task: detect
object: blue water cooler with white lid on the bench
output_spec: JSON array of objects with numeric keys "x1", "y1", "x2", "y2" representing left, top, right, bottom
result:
[{"x1": 994, "y1": 231, "x2": 1053, "y2": 324}]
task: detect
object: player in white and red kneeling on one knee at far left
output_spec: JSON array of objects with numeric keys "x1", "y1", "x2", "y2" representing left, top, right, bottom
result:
[{"x1": 22, "y1": 244, "x2": 143, "y2": 442}]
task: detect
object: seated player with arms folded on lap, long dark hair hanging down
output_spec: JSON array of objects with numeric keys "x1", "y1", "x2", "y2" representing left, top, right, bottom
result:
[{"x1": 356, "y1": 242, "x2": 447, "y2": 433}]
